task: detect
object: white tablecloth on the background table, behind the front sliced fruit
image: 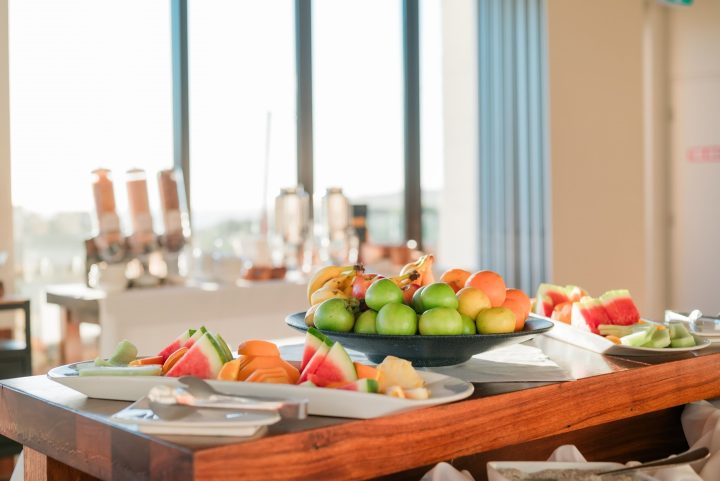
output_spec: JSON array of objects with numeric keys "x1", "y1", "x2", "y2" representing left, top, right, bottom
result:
[{"x1": 98, "y1": 281, "x2": 307, "y2": 356}]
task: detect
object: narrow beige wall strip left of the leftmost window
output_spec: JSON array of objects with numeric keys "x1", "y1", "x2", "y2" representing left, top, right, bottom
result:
[{"x1": 0, "y1": 0, "x2": 13, "y2": 288}]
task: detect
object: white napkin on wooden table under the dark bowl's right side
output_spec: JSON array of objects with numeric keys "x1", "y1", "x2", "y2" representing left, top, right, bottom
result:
[{"x1": 425, "y1": 344, "x2": 573, "y2": 382}]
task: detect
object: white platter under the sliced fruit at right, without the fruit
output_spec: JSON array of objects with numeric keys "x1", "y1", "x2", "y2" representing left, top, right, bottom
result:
[{"x1": 530, "y1": 314, "x2": 710, "y2": 357}]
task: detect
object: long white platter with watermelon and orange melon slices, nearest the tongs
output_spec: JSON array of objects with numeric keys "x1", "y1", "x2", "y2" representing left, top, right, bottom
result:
[{"x1": 48, "y1": 327, "x2": 473, "y2": 418}]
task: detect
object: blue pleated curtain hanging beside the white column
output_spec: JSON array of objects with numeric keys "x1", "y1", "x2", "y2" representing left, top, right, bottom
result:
[{"x1": 478, "y1": 0, "x2": 551, "y2": 293}]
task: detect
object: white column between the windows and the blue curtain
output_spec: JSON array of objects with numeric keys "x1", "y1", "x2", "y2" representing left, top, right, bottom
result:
[{"x1": 438, "y1": 0, "x2": 480, "y2": 270}]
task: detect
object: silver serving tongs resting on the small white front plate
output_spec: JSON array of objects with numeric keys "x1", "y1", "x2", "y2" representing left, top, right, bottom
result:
[{"x1": 148, "y1": 376, "x2": 307, "y2": 420}]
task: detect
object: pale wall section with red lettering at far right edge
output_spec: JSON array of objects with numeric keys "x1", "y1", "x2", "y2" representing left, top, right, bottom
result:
[{"x1": 670, "y1": 0, "x2": 720, "y2": 314}]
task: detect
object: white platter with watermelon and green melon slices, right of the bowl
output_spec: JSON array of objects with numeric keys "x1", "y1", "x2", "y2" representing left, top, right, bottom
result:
[{"x1": 531, "y1": 284, "x2": 710, "y2": 356}]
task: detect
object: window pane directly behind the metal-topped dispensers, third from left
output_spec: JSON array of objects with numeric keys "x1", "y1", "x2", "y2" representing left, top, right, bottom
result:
[{"x1": 312, "y1": 0, "x2": 405, "y2": 243}]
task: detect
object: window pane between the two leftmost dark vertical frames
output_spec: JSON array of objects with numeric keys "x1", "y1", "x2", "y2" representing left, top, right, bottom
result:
[{"x1": 188, "y1": 0, "x2": 297, "y2": 251}]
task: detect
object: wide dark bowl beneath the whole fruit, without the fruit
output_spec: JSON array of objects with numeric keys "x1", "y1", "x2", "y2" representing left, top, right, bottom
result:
[{"x1": 285, "y1": 312, "x2": 553, "y2": 367}]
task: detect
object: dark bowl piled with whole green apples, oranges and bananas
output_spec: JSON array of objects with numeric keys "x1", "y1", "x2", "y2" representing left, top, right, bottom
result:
[{"x1": 286, "y1": 255, "x2": 552, "y2": 366}]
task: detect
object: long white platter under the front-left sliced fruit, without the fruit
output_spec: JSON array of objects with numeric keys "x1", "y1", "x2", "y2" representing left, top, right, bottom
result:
[{"x1": 48, "y1": 361, "x2": 474, "y2": 419}]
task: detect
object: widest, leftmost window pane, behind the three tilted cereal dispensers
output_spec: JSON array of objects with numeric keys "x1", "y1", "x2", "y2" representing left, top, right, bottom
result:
[{"x1": 9, "y1": 0, "x2": 172, "y2": 339}]
